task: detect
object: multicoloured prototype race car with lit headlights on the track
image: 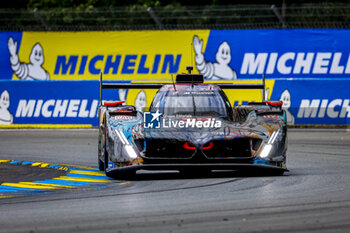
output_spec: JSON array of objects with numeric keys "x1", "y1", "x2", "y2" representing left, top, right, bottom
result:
[{"x1": 98, "y1": 70, "x2": 288, "y2": 177}]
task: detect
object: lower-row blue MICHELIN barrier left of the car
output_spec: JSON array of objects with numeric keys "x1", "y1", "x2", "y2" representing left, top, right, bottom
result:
[{"x1": 0, "y1": 80, "x2": 126, "y2": 126}]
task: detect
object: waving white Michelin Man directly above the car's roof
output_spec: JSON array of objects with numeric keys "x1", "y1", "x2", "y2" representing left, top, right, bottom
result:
[{"x1": 193, "y1": 36, "x2": 237, "y2": 80}]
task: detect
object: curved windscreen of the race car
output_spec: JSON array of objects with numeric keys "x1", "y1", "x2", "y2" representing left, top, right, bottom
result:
[{"x1": 152, "y1": 90, "x2": 226, "y2": 117}]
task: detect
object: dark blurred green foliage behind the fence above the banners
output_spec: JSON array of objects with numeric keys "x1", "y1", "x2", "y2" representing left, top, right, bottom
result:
[{"x1": 0, "y1": 0, "x2": 350, "y2": 31}]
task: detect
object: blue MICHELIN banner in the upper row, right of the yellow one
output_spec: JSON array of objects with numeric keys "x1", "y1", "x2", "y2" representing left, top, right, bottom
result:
[{"x1": 205, "y1": 29, "x2": 350, "y2": 79}]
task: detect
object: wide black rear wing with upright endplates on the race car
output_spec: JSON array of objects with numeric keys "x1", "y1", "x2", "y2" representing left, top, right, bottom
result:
[{"x1": 100, "y1": 73, "x2": 266, "y2": 103}]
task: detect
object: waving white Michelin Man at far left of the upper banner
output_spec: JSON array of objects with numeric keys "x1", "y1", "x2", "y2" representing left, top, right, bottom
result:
[{"x1": 8, "y1": 37, "x2": 50, "y2": 80}]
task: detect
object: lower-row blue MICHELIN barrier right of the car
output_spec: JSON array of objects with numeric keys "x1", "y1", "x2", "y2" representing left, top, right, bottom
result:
[{"x1": 271, "y1": 79, "x2": 350, "y2": 125}]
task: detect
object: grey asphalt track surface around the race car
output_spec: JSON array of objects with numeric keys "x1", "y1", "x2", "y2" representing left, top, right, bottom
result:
[{"x1": 0, "y1": 129, "x2": 350, "y2": 232}]
